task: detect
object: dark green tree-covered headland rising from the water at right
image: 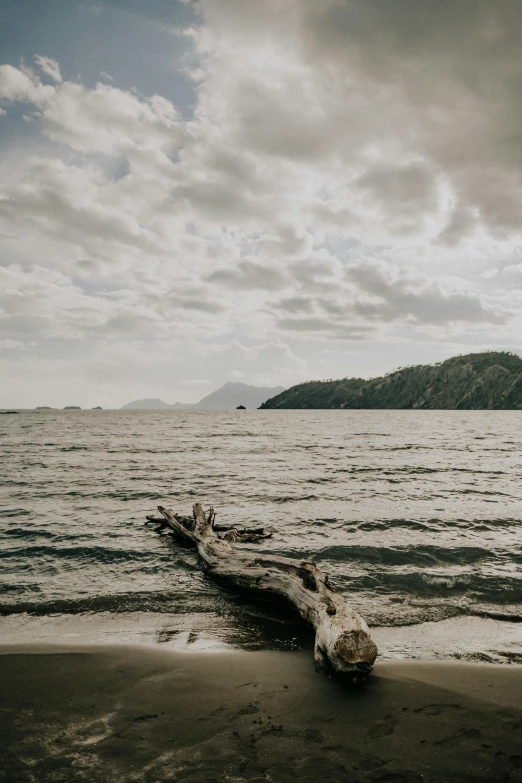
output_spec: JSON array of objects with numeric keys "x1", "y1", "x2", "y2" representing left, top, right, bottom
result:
[{"x1": 261, "y1": 351, "x2": 522, "y2": 410}]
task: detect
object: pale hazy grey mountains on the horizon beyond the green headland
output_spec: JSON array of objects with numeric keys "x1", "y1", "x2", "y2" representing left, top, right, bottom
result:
[{"x1": 123, "y1": 383, "x2": 284, "y2": 410}]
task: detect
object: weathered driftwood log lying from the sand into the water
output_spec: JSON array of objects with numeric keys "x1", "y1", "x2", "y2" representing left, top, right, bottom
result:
[{"x1": 146, "y1": 503, "x2": 377, "y2": 682}]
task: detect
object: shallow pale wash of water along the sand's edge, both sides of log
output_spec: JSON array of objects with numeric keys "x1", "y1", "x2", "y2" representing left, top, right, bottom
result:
[{"x1": 0, "y1": 612, "x2": 522, "y2": 666}]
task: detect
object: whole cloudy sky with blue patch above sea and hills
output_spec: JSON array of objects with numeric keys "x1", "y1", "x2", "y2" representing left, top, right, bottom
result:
[{"x1": 0, "y1": 0, "x2": 522, "y2": 407}]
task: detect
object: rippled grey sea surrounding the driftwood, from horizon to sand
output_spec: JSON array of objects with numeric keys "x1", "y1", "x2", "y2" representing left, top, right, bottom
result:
[{"x1": 0, "y1": 411, "x2": 522, "y2": 662}]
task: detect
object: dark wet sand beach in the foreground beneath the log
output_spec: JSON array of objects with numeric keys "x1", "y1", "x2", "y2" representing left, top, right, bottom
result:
[{"x1": 0, "y1": 647, "x2": 522, "y2": 783}]
